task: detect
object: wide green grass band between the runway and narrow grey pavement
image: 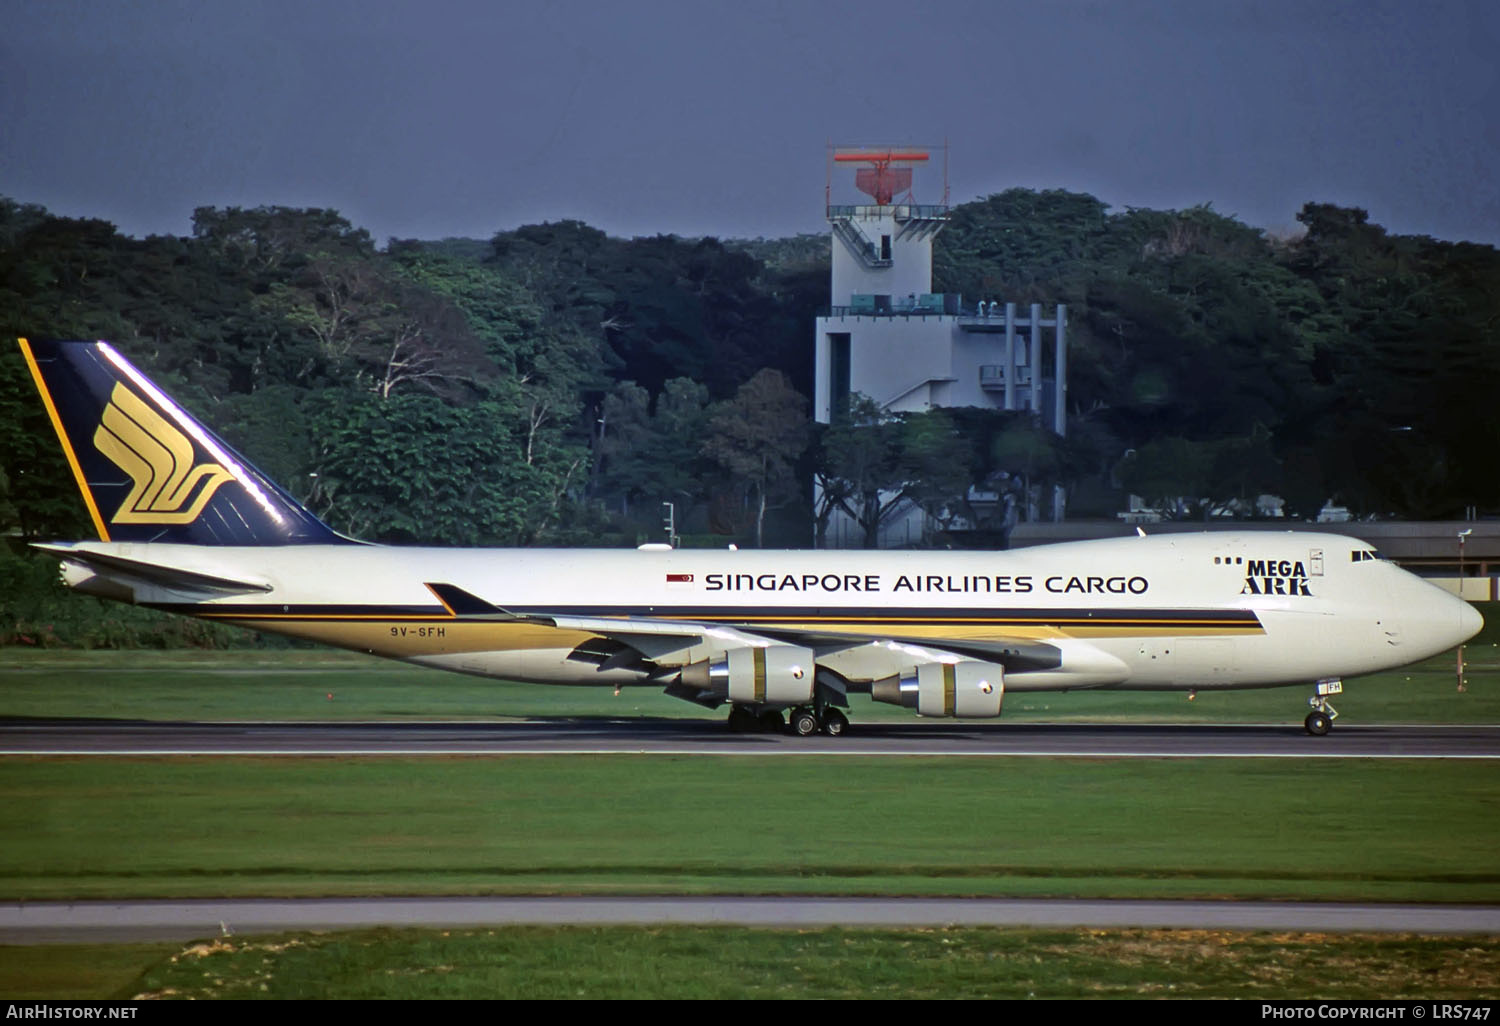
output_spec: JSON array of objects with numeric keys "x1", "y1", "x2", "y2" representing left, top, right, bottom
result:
[{"x1": 0, "y1": 755, "x2": 1500, "y2": 902}]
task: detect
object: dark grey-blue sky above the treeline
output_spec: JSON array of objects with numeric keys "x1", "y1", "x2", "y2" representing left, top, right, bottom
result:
[{"x1": 0, "y1": 0, "x2": 1500, "y2": 243}]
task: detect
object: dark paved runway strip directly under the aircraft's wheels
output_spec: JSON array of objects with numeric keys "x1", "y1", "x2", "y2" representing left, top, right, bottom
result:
[{"x1": 0, "y1": 719, "x2": 1500, "y2": 759}]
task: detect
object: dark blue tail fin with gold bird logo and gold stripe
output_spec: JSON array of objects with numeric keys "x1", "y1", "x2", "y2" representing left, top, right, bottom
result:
[{"x1": 21, "y1": 339, "x2": 350, "y2": 545}]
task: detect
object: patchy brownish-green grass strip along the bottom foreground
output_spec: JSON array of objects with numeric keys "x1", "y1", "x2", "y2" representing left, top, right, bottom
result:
[{"x1": 0, "y1": 927, "x2": 1500, "y2": 1001}]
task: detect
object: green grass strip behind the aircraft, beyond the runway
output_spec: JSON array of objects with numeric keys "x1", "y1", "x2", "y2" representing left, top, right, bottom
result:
[{"x1": 0, "y1": 630, "x2": 1500, "y2": 725}]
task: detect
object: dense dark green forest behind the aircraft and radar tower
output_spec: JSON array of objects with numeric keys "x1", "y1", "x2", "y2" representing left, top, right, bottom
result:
[{"x1": 0, "y1": 189, "x2": 1500, "y2": 570}]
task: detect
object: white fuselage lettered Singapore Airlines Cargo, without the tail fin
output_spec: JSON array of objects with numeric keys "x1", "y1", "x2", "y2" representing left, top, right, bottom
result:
[{"x1": 59, "y1": 531, "x2": 1481, "y2": 690}]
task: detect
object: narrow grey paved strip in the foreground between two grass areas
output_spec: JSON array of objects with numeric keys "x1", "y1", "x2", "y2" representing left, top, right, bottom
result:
[{"x1": 0, "y1": 897, "x2": 1500, "y2": 944}]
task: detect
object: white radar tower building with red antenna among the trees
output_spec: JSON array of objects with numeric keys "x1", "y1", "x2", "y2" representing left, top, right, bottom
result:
[{"x1": 813, "y1": 147, "x2": 1067, "y2": 548}]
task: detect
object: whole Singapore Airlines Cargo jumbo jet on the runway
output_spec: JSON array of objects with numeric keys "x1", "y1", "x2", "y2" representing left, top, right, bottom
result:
[{"x1": 21, "y1": 339, "x2": 1482, "y2": 735}]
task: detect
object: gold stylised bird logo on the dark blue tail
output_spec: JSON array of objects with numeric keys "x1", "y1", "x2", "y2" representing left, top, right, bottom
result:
[{"x1": 95, "y1": 383, "x2": 231, "y2": 524}]
